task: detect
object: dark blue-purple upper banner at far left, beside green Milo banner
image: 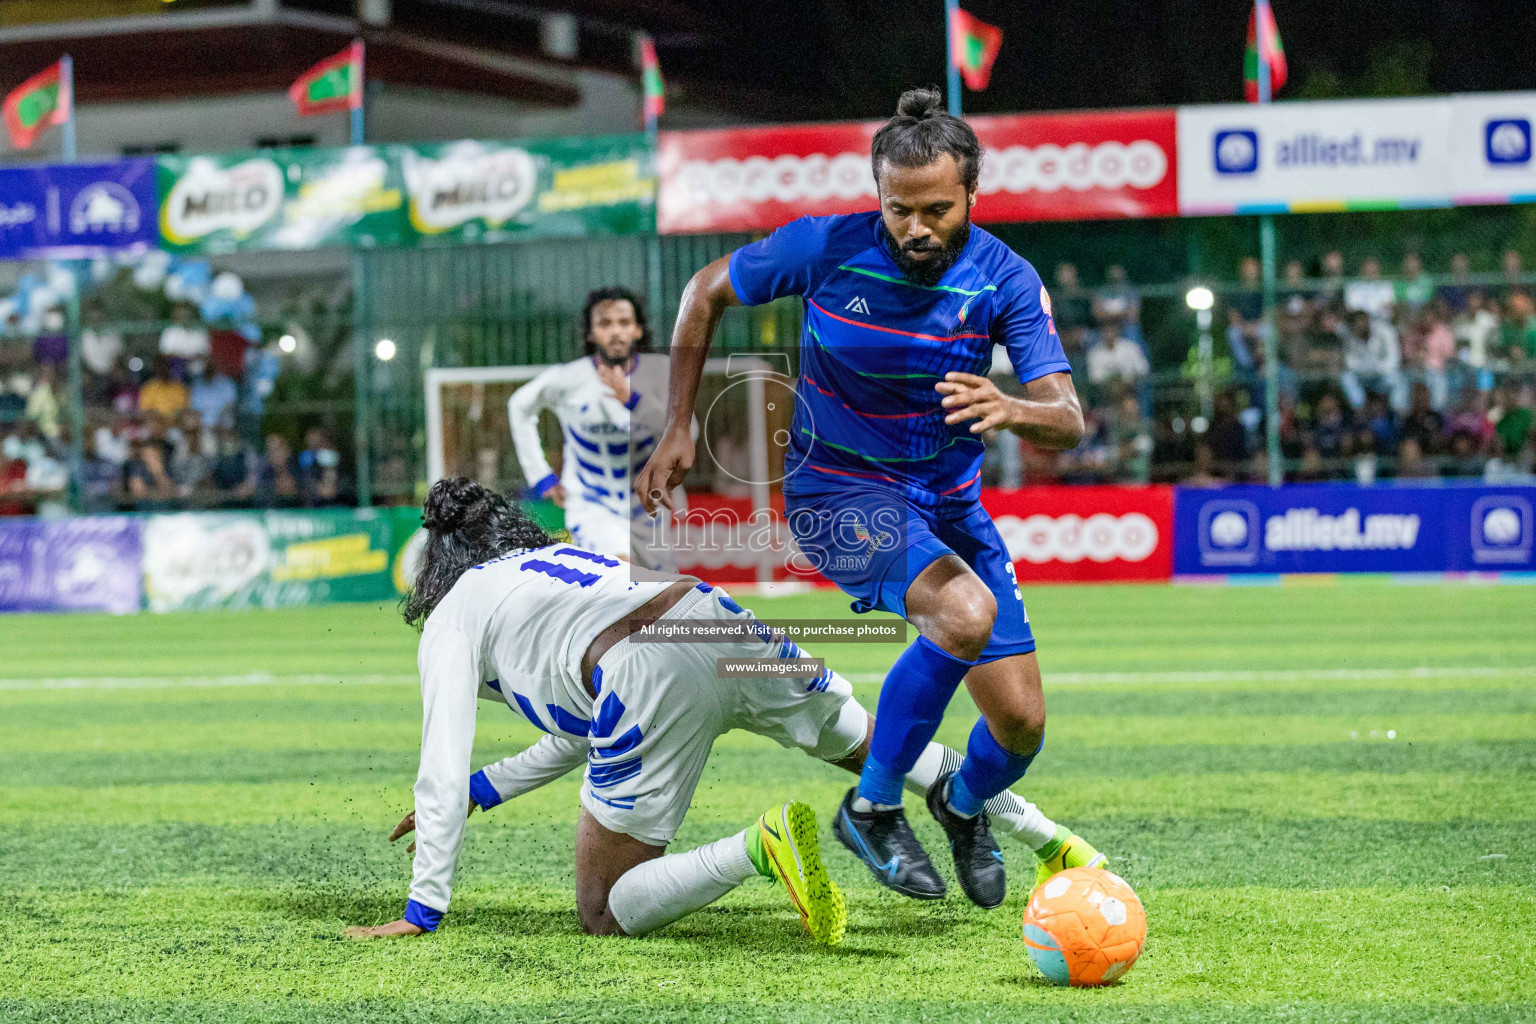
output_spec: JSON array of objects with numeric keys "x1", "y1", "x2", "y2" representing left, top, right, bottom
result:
[{"x1": 0, "y1": 158, "x2": 155, "y2": 259}]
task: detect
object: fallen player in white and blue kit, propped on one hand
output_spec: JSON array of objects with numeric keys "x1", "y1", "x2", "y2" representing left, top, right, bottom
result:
[{"x1": 349, "y1": 479, "x2": 1105, "y2": 944}]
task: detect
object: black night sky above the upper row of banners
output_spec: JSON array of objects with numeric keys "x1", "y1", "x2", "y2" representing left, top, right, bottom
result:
[{"x1": 657, "y1": 0, "x2": 1536, "y2": 120}]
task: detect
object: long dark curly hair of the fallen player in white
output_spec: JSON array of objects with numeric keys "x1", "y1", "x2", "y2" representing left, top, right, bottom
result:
[{"x1": 399, "y1": 476, "x2": 554, "y2": 629}]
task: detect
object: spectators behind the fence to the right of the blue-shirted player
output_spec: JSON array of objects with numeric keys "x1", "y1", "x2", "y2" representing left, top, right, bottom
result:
[{"x1": 1019, "y1": 249, "x2": 1536, "y2": 485}]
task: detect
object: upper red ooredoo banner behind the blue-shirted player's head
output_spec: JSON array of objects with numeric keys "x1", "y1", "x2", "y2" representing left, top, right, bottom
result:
[{"x1": 657, "y1": 111, "x2": 1178, "y2": 233}]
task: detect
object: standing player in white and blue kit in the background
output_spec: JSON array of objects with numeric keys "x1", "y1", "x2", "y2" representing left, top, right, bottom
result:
[{"x1": 507, "y1": 287, "x2": 680, "y2": 570}]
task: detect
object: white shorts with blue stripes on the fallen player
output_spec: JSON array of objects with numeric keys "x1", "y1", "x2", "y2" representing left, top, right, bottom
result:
[{"x1": 581, "y1": 583, "x2": 868, "y2": 846}]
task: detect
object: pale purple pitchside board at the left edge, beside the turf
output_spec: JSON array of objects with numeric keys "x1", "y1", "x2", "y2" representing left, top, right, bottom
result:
[{"x1": 0, "y1": 516, "x2": 143, "y2": 614}]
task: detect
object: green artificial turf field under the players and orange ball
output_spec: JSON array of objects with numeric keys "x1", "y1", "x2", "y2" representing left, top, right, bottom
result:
[{"x1": 0, "y1": 585, "x2": 1536, "y2": 1024}]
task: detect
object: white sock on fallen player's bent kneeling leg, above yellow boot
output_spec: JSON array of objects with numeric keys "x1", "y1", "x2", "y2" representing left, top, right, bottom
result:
[{"x1": 608, "y1": 826, "x2": 757, "y2": 935}]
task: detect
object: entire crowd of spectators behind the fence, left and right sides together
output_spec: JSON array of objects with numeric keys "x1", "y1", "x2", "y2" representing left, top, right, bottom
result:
[{"x1": 0, "y1": 250, "x2": 1536, "y2": 514}]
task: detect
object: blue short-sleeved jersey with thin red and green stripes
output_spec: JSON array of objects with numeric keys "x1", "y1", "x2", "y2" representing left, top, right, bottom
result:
[{"x1": 731, "y1": 212, "x2": 1071, "y2": 507}]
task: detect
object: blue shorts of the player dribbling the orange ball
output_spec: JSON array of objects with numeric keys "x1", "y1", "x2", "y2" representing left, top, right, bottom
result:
[{"x1": 783, "y1": 484, "x2": 1035, "y2": 662}]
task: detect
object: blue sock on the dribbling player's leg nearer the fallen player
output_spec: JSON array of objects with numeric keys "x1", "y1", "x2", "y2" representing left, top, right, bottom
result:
[{"x1": 859, "y1": 636, "x2": 975, "y2": 806}]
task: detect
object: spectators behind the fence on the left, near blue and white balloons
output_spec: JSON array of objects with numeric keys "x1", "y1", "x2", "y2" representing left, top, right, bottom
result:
[{"x1": 0, "y1": 304, "x2": 352, "y2": 514}]
